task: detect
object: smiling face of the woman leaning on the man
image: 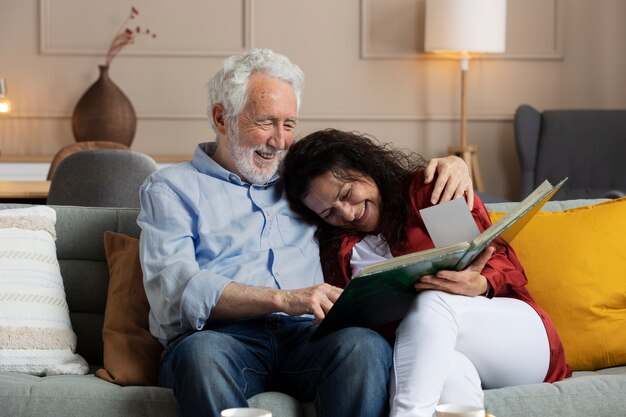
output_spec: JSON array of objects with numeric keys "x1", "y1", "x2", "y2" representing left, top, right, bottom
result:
[{"x1": 302, "y1": 172, "x2": 381, "y2": 233}]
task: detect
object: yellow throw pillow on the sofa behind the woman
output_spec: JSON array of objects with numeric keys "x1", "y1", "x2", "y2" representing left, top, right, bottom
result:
[{"x1": 490, "y1": 198, "x2": 626, "y2": 370}]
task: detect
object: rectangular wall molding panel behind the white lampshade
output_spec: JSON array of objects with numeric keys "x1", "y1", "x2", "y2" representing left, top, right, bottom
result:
[{"x1": 360, "y1": 0, "x2": 565, "y2": 60}]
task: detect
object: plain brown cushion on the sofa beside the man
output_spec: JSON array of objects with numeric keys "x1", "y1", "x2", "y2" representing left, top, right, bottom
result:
[{"x1": 96, "y1": 231, "x2": 163, "y2": 385}]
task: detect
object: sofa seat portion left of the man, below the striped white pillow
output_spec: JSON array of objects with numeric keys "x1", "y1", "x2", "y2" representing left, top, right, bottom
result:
[{"x1": 0, "y1": 372, "x2": 177, "y2": 417}]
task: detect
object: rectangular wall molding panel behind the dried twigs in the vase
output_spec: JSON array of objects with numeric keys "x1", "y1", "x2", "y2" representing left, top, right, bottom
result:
[{"x1": 39, "y1": 0, "x2": 254, "y2": 57}]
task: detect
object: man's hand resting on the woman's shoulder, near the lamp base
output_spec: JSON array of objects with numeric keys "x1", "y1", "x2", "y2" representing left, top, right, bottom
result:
[{"x1": 424, "y1": 155, "x2": 474, "y2": 210}]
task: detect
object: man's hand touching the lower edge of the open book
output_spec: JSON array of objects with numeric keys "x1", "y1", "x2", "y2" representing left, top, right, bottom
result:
[{"x1": 281, "y1": 284, "x2": 343, "y2": 323}]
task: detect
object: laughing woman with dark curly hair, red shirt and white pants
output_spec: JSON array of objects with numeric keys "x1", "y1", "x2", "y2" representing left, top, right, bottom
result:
[{"x1": 284, "y1": 129, "x2": 569, "y2": 417}]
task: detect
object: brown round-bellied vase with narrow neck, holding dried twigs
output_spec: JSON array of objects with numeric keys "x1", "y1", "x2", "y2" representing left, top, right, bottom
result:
[{"x1": 72, "y1": 65, "x2": 137, "y2": 147}]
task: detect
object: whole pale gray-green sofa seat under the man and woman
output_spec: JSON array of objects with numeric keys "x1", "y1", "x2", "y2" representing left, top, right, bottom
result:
[{"x1": 0, "y1": 366, "x2": 626, "y2": 417}]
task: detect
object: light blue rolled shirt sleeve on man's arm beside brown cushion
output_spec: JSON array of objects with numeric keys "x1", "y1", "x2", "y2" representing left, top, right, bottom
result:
[{"x1": 137, "y1": 179, "x2": 231, "y2": 340}]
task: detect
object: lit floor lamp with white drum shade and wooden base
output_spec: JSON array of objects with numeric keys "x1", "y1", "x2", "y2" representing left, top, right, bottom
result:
[{"x1": 424, "y1": 0, "x2": 506, "y2": 191}]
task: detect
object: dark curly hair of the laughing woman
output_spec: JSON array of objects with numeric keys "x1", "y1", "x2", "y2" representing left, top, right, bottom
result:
[{"x1": 283, "y1": 129, "x2": 425, "y2": 254}]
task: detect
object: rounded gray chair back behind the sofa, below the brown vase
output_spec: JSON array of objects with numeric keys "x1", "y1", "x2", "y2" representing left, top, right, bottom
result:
[{"x1": 46, "y1": 149, "x2": 158, "y2": 208}]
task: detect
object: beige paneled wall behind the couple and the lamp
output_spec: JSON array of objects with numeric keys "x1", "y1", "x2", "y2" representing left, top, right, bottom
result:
[{"x1": 0, "y1": 0, "x2": 626, "y2": 198}]
